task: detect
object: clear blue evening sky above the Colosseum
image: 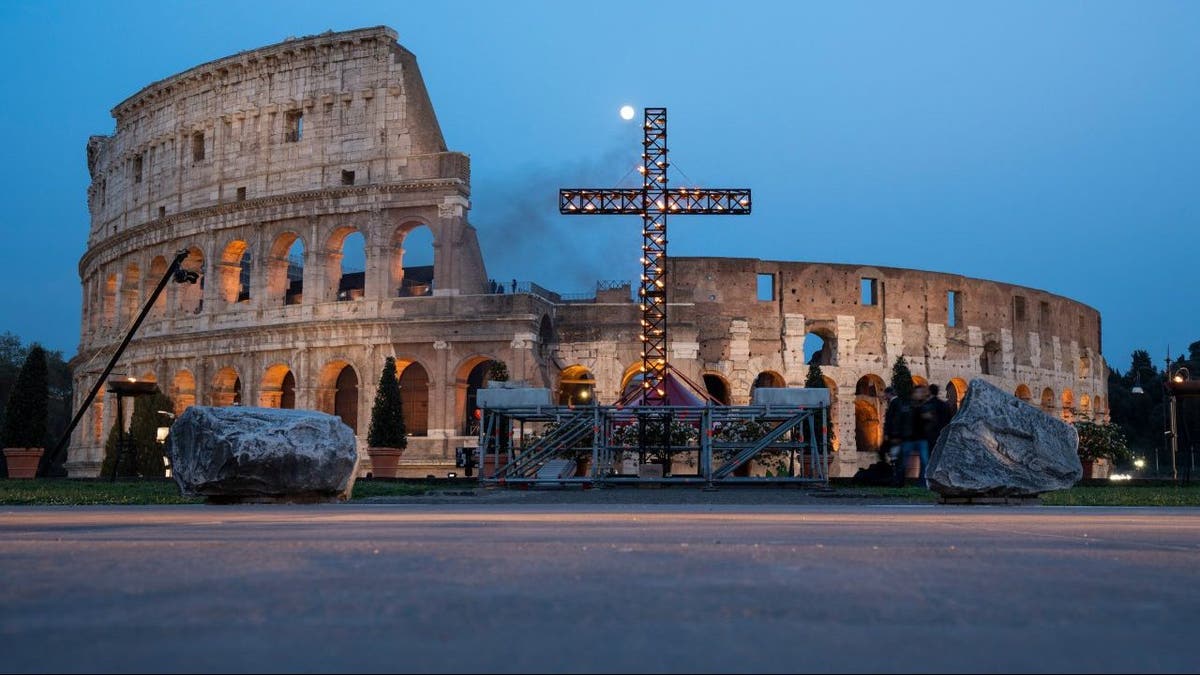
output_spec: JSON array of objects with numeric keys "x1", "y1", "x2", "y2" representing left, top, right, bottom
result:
[{"x1": 0, "y1": 0, "x2": 1200, "y2": 369}]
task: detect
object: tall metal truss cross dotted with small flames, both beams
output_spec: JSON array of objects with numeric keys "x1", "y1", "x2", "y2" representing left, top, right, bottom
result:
[{"x1": 558, "y1": 108, "x2": 750, "y2": 405}]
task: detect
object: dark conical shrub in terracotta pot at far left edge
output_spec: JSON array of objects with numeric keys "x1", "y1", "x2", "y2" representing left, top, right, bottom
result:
[{"x1": 0, "y1": 345, "x2": 49, "y2": 478}]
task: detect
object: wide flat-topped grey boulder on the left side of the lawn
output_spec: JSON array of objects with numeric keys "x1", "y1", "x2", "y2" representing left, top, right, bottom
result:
[{"x1": 167, "y1": 406, "x2": 358, "y2": 501}]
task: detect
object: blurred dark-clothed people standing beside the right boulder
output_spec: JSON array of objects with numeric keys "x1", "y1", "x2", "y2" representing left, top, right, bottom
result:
[{"x1": 880, "y1": 384, "x2": 953, "y2": 486}]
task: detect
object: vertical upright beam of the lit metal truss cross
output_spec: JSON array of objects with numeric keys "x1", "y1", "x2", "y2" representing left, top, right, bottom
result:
[{"x1": 638, "y1": 108, "x2": 668, "y2": 405}]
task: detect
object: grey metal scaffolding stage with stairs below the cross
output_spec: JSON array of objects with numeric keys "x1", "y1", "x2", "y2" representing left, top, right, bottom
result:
[{"x1": 476, "y1": 405, "x2": 829, "y2": 485}]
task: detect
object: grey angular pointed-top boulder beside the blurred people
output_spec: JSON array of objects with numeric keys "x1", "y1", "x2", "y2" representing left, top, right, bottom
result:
[{"x1": 925, "y1": 380, "x2": 1084, "y2": 497}]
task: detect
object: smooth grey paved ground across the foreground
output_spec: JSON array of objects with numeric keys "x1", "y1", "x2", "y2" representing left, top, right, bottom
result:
[{"x1": 0, "y1": 498, "x2": 1200, "y2": 673}]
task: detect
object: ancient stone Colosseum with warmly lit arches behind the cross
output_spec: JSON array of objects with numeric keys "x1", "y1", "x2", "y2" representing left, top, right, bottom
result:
[{"x1": 67, "y1": 26, "x2": 1106, "y2": 477}]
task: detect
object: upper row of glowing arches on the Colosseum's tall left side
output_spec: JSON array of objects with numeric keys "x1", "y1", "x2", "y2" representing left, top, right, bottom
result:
[{"x1": 84, "y1": 222, "x2": 434, "y2": 329}]
